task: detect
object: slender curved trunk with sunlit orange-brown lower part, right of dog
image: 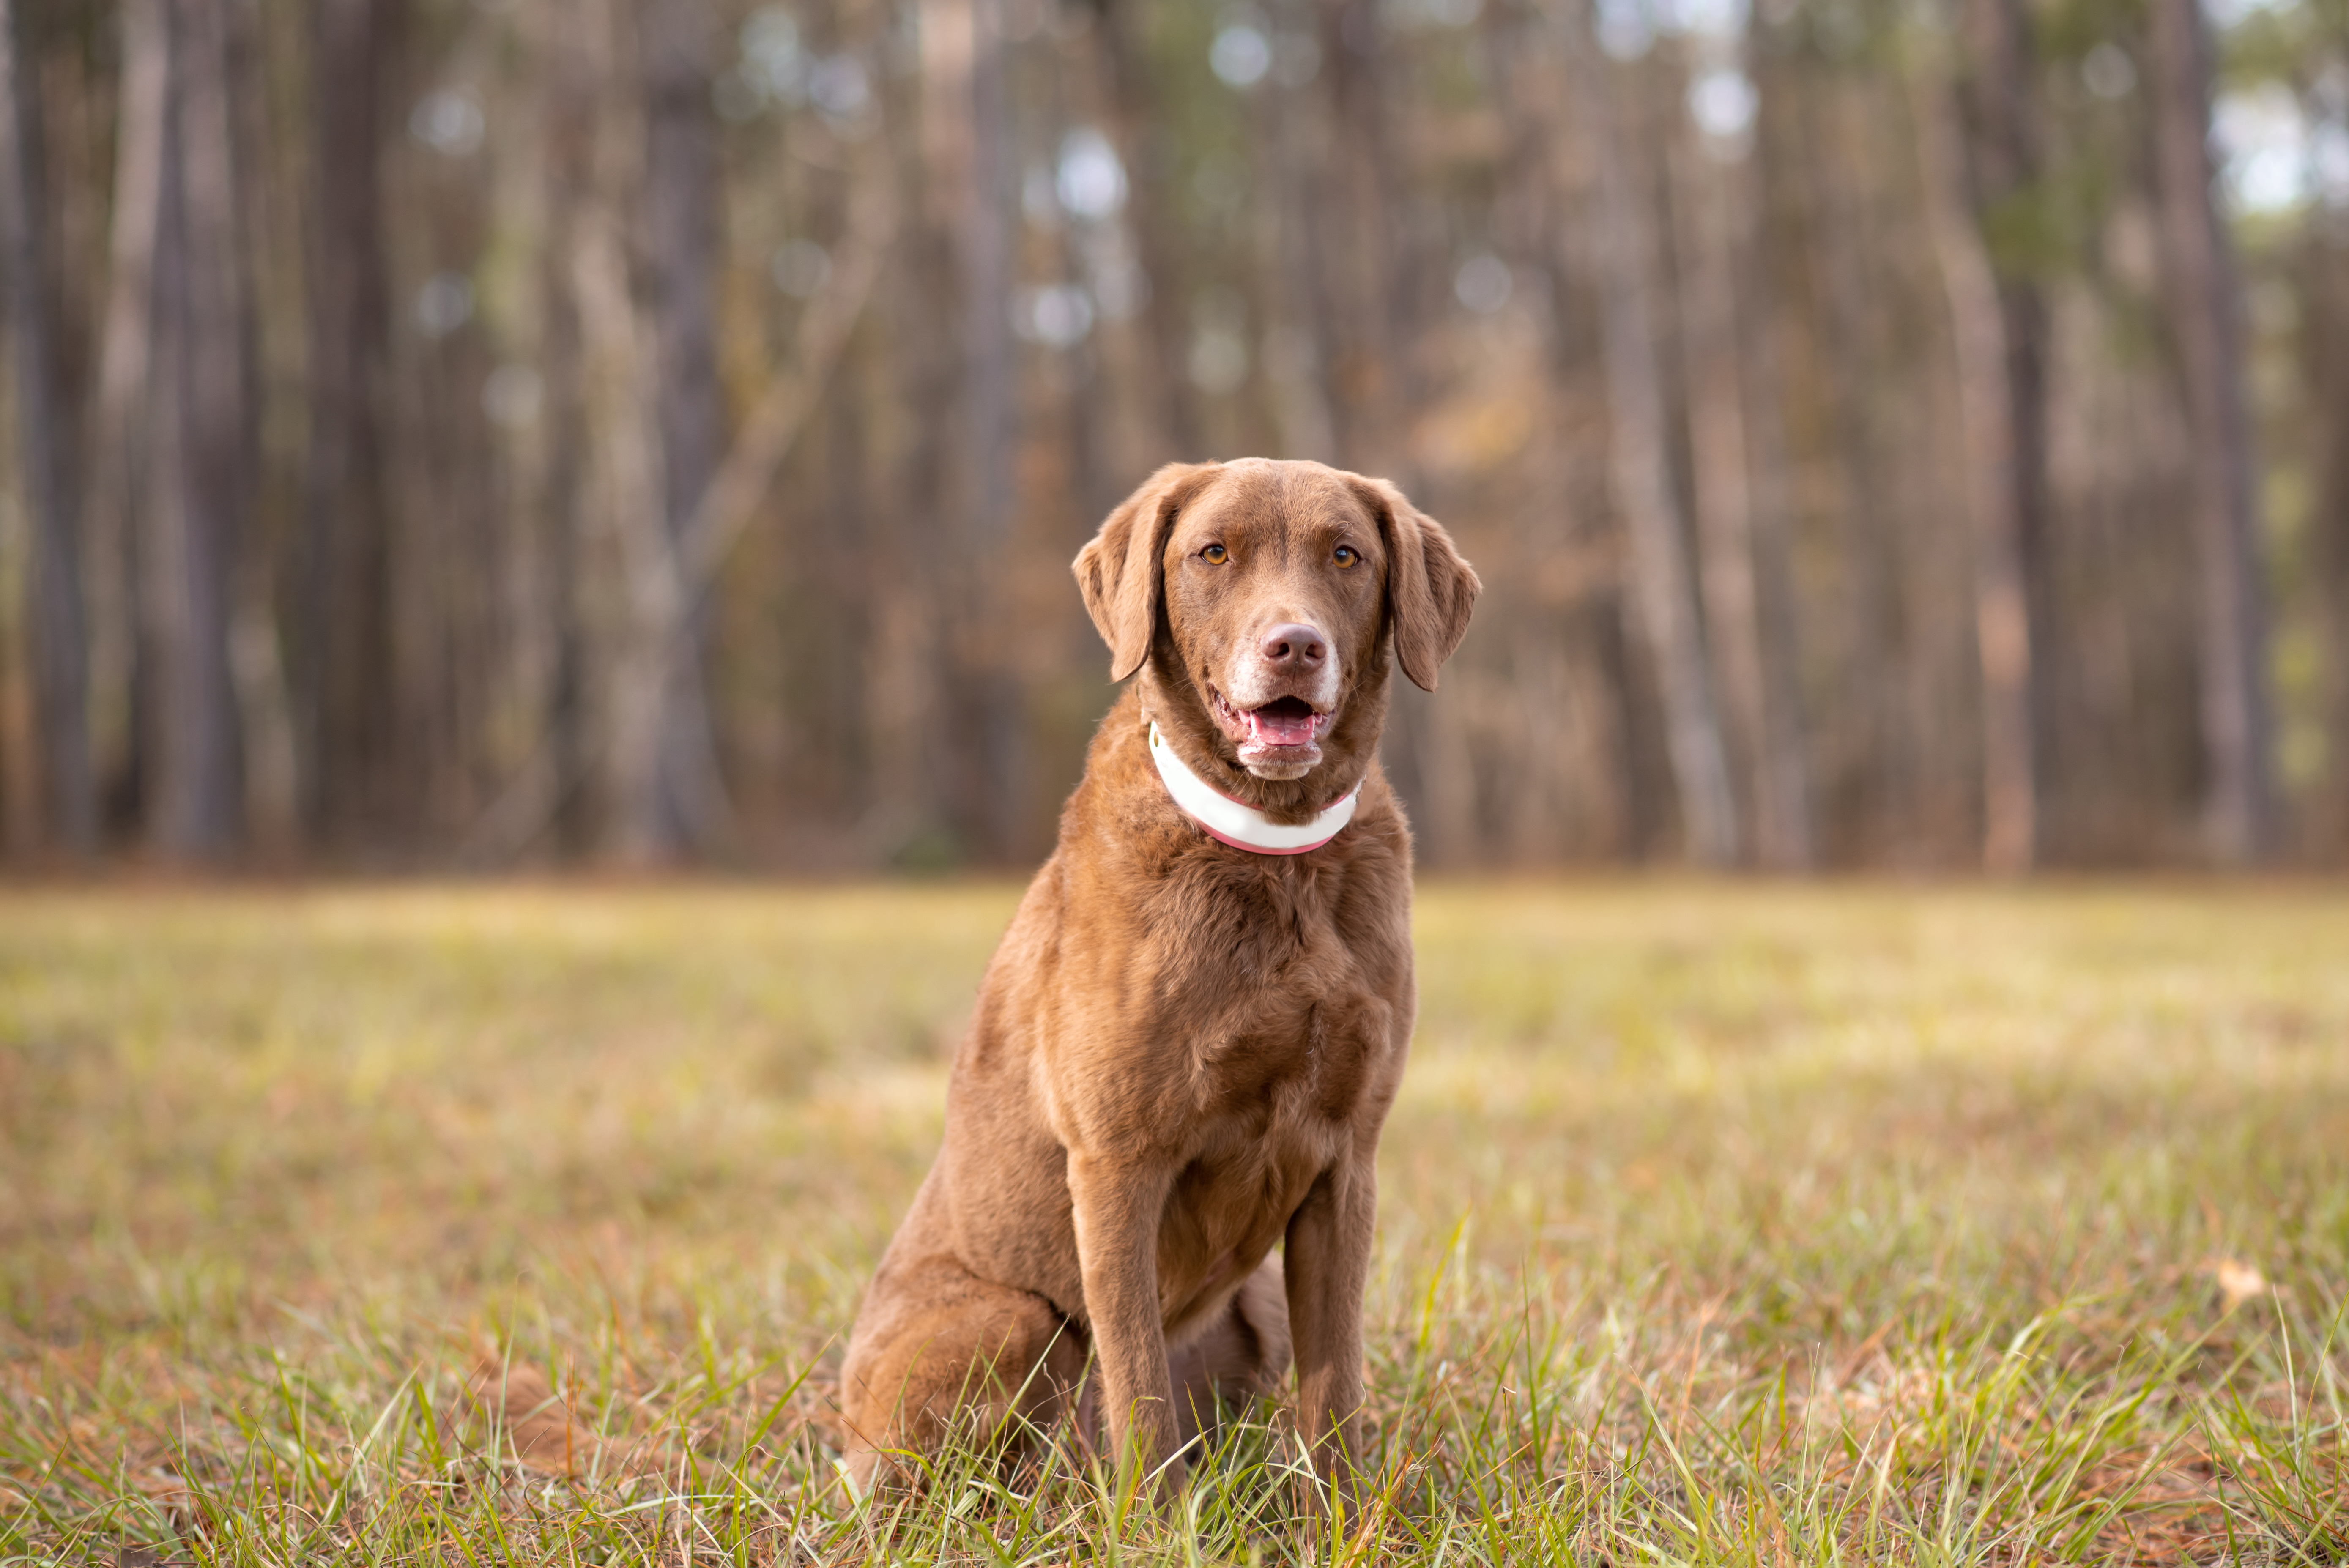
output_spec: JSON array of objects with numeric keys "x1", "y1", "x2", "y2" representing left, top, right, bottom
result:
[{"x1": 1910, "y1": 61, "x2": 2039, "y2": 873}]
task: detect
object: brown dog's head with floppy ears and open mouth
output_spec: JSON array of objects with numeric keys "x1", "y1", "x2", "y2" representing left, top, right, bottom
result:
[{"x1": 1076, "y1": 458, "x2": 1480, "y2": 807}]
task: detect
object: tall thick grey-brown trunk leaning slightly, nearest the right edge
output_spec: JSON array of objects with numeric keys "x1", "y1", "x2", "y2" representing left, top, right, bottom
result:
[{"x1": 2147, "y1": 0, "x2": 2274, "y2": 864}]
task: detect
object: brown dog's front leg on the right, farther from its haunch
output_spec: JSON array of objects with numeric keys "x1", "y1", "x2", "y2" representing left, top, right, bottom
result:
[{"x1": 1283, "y1": 1155, "x2": 1379, "y2": 1512}]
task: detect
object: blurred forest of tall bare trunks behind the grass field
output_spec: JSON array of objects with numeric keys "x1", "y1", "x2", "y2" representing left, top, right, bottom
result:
[{"x1": 0, "y1": 0, "x2": 2349, "y2": 871}]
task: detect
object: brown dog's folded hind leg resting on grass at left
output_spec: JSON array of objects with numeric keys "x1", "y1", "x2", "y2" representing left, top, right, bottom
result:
[{"x1": 841, "y1": 1249, "x2": 1085, "y2": 1491}]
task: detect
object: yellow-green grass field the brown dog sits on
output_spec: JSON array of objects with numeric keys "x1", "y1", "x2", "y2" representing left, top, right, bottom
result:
[{"x1": 0, "y1": 883, "x2": 2349, "y2": 1568}]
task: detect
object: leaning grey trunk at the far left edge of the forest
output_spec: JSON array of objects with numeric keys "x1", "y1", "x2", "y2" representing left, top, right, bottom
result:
[{"x1": 0, "y1": 0, "x2": 99, "y2": 854}]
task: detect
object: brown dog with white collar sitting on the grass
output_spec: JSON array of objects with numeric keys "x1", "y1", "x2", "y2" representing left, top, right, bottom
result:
[{"x1": 841, "y1": 460, "x2": 1478, "y2": 1483}]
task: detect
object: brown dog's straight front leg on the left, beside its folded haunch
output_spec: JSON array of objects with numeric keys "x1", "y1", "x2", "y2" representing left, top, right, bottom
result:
[{"x1": 1069, "y1": 1152, "x2": 1184, "y2": 1483}]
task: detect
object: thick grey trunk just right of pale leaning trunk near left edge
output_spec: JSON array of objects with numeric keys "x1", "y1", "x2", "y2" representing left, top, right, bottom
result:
[{"x1": 139, "y1": 7, "x2": 251, "y2": 859}]
